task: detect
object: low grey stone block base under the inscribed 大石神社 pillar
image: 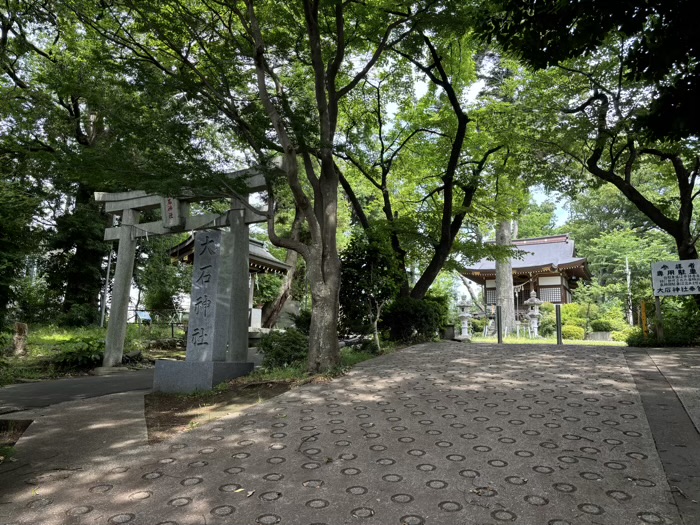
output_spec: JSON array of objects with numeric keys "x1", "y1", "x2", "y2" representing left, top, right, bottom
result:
[{"x1": 153, "y1": 359, "x2": 253, "y2": 394}]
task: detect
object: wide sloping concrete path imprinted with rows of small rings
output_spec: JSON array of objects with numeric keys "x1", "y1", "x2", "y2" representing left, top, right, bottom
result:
[{"x1": 0, "y1": 343, "x2": 693, "y2": 525}]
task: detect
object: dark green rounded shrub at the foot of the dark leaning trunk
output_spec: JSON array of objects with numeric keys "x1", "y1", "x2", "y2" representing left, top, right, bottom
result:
[{"x1": 384, "y1": 296, "x2": 448, "y2": 342}]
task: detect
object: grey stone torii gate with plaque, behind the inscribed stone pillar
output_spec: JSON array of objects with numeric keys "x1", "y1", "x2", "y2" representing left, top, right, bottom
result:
[{"x1": 95, "y1": 168, "x2": 268, "y2": 391}]
